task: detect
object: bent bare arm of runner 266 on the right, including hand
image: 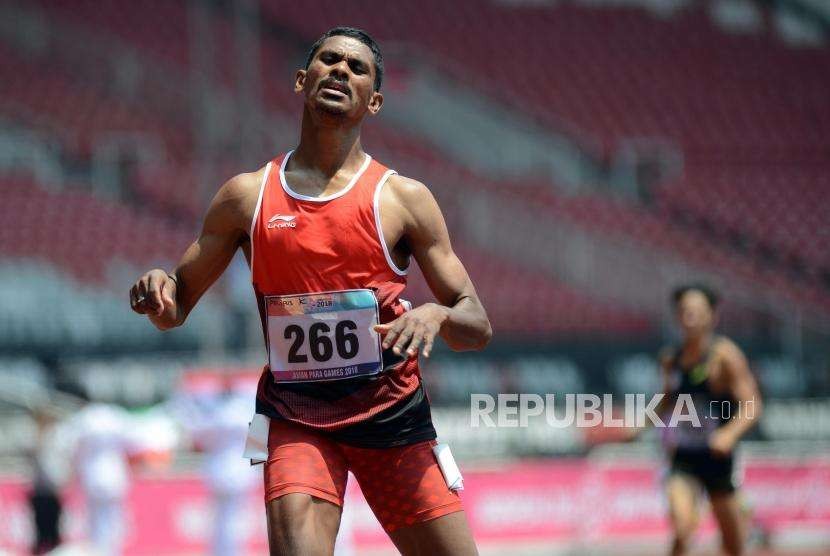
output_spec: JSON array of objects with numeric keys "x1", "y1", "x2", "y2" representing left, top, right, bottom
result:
[{"x1": 378, "y1": 176, "x2": 493, "y2": 357}]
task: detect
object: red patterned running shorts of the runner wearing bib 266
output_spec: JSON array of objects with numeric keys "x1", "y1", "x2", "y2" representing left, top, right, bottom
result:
[{"x1": 265, "y1": 420, "x2": 462, "y2": 532}]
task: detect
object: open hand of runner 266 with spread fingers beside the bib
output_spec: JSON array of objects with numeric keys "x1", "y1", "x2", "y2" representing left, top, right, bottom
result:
[{"x1": 374, "y1": 303, "x2": 449, "y2": 357}]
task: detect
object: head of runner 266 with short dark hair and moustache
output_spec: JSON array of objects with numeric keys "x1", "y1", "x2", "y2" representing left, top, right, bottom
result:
[{"x1": 294, "y1": 37, "x2": 383, "y2": 119}]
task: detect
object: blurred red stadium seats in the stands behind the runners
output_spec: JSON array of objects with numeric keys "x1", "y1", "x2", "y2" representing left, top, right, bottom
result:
[{"x1": 0, "y1": 1, "x2": 830, "y2": 390}]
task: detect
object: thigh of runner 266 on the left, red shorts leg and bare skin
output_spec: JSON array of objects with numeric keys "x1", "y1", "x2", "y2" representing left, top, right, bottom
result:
[{"x1": 264, "y1": 421, "x2": 347, "y2": 556}]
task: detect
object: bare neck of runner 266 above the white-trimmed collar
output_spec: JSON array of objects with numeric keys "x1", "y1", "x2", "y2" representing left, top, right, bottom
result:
[{"x1": 291, "y1": 107, "x2": 365, "y2": 178}]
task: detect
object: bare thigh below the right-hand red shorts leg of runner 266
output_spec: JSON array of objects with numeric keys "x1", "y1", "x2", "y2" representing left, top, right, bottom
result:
[{"x1": 389, "y1": 511, "x2": 478, "y2": 556}]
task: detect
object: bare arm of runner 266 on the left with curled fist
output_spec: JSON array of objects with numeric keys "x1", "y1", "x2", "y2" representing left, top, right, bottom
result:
[{"x1": 130, "y1": 172, "x2": 260, "y2": 330}]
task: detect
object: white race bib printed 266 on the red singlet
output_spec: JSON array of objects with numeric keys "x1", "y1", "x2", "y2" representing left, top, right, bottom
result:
[{"x1": 265, "y1": 290, "x2": 383, "y2": 382}]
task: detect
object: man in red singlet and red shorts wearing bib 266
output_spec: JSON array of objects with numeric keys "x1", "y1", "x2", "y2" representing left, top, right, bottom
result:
[{"x1": 130, "y1": 27, "x2": 492, "y2": 555}]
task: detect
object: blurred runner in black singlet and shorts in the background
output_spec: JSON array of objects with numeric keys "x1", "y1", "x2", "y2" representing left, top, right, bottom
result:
[{"x1": 660, "y1": 284, "x2": 761, "y2": 556}]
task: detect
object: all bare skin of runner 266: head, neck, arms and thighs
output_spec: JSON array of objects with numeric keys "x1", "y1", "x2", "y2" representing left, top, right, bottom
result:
[{"x1": 130, "y1": 36, "x2": 492, "y2": 556}]
